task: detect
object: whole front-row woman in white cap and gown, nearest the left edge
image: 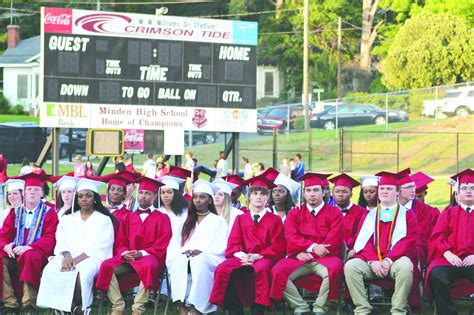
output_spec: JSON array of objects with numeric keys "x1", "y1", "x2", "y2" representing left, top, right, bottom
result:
[{"x1": 37, "y1": 178, "x2": 115, "y2": 314}]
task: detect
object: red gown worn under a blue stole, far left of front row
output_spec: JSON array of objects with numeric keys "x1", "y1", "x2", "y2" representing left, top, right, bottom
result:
[{"x1": 0, "y1": 208, "x2": 58, "y2": 296}]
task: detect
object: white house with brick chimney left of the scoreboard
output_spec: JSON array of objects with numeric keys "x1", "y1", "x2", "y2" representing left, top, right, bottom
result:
[{"x1": 0, "y1": 25, "x2": 40, "y2": 111}]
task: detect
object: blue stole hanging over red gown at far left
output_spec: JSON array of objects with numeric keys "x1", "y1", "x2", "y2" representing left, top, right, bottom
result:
[{"x1": 14, "y1": 201, "x2": 50, "y2": 247}]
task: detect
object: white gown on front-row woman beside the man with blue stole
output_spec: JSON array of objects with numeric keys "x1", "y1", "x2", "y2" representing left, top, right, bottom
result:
[{"x1": 37, "y1": 211, "x2": 114, "y2": 312}]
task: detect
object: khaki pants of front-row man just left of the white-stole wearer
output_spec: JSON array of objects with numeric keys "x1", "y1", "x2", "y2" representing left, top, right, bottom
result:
[{"x1": 283, "y1": 261, "x2": 329, "y2": 313}]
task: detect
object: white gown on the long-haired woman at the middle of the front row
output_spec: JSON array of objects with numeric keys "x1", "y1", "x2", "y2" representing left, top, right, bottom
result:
[{"x1": 166, "y1": 213, "x2": 228, "y2": 313}]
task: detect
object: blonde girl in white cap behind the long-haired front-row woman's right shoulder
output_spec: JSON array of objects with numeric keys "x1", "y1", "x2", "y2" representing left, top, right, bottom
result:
[{"x1": 212, "y1": 178, "x2": 244, "y2": 234}]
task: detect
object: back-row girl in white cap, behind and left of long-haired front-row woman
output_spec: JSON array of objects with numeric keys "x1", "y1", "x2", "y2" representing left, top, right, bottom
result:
[{"x1": 158, "y1": 176, "x2": 188, "y2": 235}]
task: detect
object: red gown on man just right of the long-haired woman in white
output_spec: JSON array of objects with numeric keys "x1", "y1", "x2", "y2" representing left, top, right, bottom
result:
[{"x1": 209, "y1": 210, "x2": 285, "y2": 307}]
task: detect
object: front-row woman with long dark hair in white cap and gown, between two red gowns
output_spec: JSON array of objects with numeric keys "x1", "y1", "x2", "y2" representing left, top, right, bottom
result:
[{"x1": 166, "y1": 179, "x2": 228, "y2": 315}]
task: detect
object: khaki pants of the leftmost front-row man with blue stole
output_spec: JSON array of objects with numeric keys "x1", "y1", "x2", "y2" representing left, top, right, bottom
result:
[{"x1": 2, "y1": 257, "x2": 38, "y2": 308}]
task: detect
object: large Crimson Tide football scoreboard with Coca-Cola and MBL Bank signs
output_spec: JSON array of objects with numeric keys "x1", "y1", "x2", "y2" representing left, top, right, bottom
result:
[{"x1": 40, "y1": 8, "x2": 257, "y2": 132}]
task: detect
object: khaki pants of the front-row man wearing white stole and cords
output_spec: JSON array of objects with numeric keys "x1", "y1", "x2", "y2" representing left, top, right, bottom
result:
[{"x1": 344, "y1": 256, "x2": 413, "y2": 314}]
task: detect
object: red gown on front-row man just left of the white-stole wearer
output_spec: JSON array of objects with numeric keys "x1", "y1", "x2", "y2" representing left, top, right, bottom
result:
[{"x1": 270, "y1": 204, "x2": 344, "y2": 301}]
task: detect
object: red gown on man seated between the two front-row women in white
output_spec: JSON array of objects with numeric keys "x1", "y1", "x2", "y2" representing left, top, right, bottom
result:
[{"x1": 96, "y1": 210, "x2": 171, "y2": 291}]
